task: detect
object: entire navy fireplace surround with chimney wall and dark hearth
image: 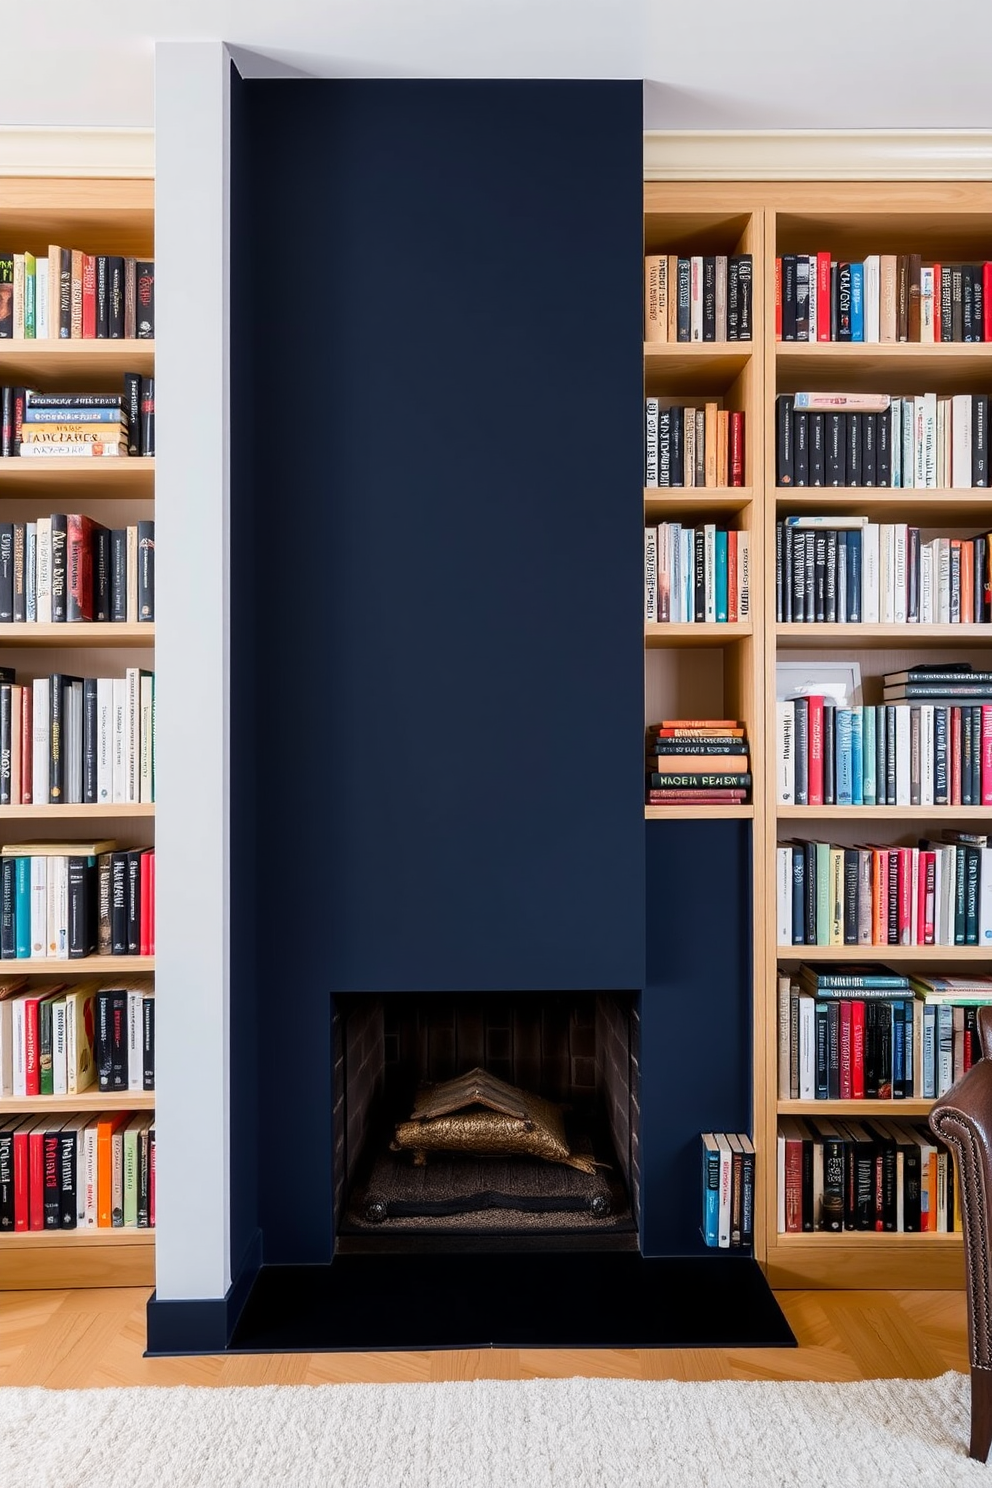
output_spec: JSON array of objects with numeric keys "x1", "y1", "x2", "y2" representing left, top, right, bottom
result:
[{"x1": 149, "y1": 74, "x2": 791, "y2": 1353}]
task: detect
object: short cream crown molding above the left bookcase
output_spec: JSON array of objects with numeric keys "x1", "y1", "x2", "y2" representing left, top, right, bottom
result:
[{"x1": 0, "y1": 124, "x2": 155, "y2": 179}]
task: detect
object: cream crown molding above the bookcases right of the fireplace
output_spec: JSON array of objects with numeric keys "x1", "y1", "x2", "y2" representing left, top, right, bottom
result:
[{"x1": 644, "y1": 129, "x2": 992, "y2": 182}]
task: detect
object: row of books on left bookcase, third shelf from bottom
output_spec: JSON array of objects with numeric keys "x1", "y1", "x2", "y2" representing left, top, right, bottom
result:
[{"x1": 0, "y1": 838, "x2": 155, "y2": 961}]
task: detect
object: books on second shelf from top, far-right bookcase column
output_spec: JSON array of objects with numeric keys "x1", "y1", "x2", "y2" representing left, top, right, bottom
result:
[{"x1": 775, "y1": 393, "x2": 989, "y2": 491}]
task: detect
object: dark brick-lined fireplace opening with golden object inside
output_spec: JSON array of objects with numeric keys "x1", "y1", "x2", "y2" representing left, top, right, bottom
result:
[{"x1": 332, "y1": 991, "x2": 640, "y2": 1251}]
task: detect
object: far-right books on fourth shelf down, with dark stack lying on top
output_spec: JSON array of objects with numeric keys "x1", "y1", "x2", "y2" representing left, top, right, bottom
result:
[{"x1": 775, "y1": 664, "x2": 992, "y2": 806}]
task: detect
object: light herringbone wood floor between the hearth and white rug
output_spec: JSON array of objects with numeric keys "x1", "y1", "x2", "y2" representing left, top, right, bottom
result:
[{"x1": 0, "y1": 1287, "x2": 968, "y2": 1390}]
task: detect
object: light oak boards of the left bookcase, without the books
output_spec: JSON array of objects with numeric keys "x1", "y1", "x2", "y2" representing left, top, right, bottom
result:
[{"x1": 0, "y1": 177, "x2": 155, "y2": 1290}]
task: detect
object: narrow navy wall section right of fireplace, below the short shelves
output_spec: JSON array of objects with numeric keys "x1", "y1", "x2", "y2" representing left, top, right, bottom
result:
[{"x1": 641, "y1": 821, "x2": 751, "y2": 1256}]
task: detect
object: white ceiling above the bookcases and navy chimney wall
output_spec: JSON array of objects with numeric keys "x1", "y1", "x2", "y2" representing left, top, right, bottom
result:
[{"x1": 0, "y1": 0, "x2": 992, "y2": 129}]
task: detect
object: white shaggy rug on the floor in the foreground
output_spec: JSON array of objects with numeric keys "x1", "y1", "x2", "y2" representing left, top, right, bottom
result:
[{"x1": 0, "y1": 1373, "x2": 992, "y2": 1488}]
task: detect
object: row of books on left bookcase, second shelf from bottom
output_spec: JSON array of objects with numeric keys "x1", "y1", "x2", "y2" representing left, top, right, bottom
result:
[{"x1": 0, "y1": 976, "x2": 155, "y2": 1098}]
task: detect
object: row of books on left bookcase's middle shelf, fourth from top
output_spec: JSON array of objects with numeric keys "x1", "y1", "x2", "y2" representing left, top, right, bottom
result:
[{"x1": 0, "y1": 667, "x2": 155, "y2": 806}]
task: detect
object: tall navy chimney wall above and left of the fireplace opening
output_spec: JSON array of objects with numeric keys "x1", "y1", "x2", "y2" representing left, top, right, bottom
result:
[{"x1": 232, "y1": 80, "x2": 645, "y2": 1260}]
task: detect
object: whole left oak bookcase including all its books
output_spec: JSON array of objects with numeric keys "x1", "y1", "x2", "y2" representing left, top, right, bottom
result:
[{"x1": 0, "y1": 179, "x2": 155, "y2": 1287}]
